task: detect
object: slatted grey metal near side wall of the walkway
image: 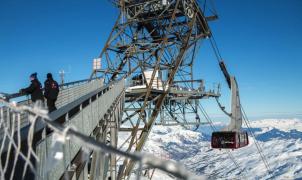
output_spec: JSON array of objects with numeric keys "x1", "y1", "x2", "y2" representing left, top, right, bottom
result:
[{"x1": 36, "y1": 81, "x2": 124, "y2": 179}]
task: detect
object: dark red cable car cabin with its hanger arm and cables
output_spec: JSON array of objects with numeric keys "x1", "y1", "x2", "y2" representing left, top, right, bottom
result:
[{"x1": 206, "y1": 35, "x2": 271, "y2": 174}]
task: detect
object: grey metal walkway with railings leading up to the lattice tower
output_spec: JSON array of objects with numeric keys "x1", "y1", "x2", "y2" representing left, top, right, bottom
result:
[{"x1": 0, "y1": 79, "x2": 125, "y2": 179}]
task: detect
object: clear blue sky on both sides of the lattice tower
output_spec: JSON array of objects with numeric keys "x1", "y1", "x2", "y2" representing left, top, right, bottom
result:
[{"x1": 0, "y1": 0, "x2": 302, "y2": 117}]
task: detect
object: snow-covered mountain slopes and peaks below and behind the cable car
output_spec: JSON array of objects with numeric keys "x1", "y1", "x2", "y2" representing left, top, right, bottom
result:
[{"x1": 144, "y1": 119, "x2": 302, "y2": 179}]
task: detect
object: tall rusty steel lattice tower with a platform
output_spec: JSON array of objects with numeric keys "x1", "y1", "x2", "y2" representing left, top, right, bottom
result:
[{"x1": 92, "y1": 0, "x2": 219, "y2": 179}]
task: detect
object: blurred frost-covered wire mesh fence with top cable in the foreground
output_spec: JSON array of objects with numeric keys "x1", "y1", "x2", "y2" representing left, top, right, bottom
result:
[{"x1": 0, "y1": 100, "x2": 205, "y2": 180}]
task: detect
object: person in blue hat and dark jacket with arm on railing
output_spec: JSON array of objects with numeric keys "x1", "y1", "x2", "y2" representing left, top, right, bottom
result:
[{"x1": 20, "y1": 73, "x2": 44, "y2": 102}]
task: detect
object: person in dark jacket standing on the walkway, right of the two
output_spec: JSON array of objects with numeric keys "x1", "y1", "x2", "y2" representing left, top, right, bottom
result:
[{"x1": 44, "y1": 73, "x2": 59, "y2": 112}]
